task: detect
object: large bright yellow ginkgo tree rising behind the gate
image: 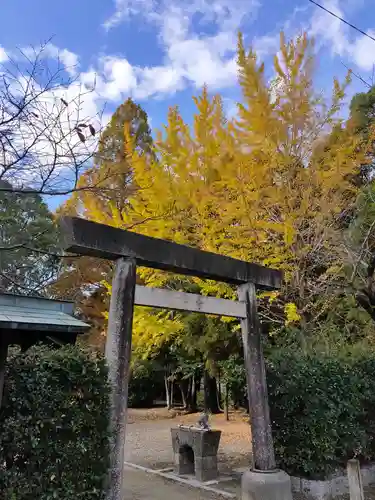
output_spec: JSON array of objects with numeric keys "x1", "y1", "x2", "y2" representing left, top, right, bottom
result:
[{"x1": 58, "y1": 30, "x2": 366, "y2": 356}]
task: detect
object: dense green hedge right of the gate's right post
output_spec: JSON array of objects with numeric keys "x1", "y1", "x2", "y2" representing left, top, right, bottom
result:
[{"x1": 267, "y1": 351, "x2": 375, "y2": 479}]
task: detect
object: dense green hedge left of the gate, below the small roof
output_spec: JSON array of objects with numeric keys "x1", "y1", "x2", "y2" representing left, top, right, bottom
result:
[{"x1": 0, "y1": 346, "x2": 109, "y2": 500}]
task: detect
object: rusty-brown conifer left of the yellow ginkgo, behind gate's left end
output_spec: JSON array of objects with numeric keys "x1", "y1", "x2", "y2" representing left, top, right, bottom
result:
[{"x1": 52, "y1": 95, "x2": 153, "y2": 350}]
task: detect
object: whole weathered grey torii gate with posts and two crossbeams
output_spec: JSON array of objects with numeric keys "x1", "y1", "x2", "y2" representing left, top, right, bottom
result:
[{"x1": 61, "y1": 217, "x2": 291, "y2": 500}]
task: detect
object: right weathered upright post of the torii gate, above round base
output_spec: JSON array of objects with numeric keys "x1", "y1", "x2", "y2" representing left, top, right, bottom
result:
[{"x1": 238, "y1": 283, "x2": 276, "y2": 471}]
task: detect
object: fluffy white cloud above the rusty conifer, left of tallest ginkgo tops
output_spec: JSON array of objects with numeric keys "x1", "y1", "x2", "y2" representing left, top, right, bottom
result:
[{"x1": 90, "y1": 31, "x2": 237, "y2": 102}]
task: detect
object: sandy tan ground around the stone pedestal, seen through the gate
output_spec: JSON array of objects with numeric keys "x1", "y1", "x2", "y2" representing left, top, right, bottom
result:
[{"x1": 124, "y1": 408, "x2": 375, "y2": 500}]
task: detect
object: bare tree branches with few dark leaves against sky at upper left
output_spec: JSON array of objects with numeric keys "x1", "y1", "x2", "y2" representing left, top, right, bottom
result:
[{"x1": 0, "y1": 42, "x2": 109, "y2": 196}]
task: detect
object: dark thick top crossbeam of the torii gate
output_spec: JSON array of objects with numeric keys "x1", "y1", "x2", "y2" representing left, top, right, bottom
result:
[{"x1": 61, "y1": 217, "x2": 282, "y2": 290}]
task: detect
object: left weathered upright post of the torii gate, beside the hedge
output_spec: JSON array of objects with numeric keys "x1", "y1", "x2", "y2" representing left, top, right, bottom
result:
[{"x1": 105, "y1": 258, "x2": 136, "y2": 500}]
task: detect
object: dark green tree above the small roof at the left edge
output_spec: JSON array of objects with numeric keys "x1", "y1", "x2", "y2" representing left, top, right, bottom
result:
[{"x1": 0, "y1": 181, "x2": 60, "y2": 295}]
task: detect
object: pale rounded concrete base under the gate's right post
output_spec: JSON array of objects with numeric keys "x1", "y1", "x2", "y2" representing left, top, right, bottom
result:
[{"x1": 241, "y1": 470, "x2": 293, "y2": 500}]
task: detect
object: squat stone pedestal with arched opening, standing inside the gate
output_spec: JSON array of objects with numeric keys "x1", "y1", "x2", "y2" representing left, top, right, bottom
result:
[{"x1": 171, "y1": 426, "x2": 221, "y2": 482}]
